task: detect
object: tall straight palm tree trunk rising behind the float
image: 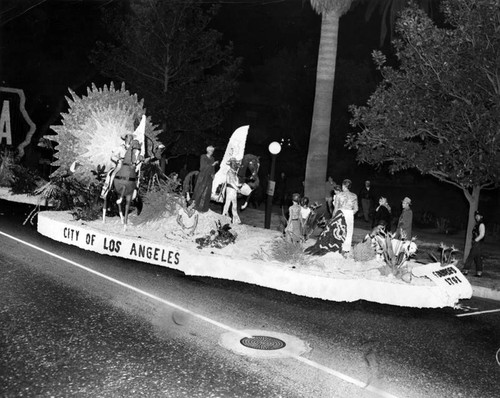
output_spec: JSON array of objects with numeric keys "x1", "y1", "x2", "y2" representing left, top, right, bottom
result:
[{"x1": 305, "y1": 11, "x2": 340, "y2": 203}]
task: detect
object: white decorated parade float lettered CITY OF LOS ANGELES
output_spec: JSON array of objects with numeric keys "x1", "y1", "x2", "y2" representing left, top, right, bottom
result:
[{"x1": 1, "y1": 85, "x2": 472, "y2": 308}]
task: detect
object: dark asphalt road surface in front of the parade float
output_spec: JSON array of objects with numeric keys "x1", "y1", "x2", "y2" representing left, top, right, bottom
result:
[{"x1": 0, "y1": 202, "x2": 500, "y2": 398}]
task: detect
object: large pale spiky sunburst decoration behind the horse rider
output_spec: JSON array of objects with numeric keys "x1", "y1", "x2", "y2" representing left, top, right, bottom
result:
[{"x1": 45, "y1": 83, "x2": 161, "y2": 180}]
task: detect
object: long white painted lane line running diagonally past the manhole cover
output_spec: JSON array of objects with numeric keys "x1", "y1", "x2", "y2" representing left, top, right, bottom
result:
[{"x1": 0, "y1": 231, "x2": 397, "y2": 398}]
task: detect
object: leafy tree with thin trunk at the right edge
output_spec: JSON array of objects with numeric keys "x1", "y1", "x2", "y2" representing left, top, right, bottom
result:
[{"x1": 347, "y1": 0, "x2": 500, "y2": 257}]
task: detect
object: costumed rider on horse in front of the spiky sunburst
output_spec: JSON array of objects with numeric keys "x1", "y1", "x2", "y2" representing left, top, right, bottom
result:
[{"x1": 101, "y1": 115, "x2": 146, "y2": 226}]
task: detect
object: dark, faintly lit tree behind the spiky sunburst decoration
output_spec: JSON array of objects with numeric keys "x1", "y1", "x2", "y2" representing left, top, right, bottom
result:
[{"x1": 92, "y1": 0, "x2": 240, "y2": 162}]
